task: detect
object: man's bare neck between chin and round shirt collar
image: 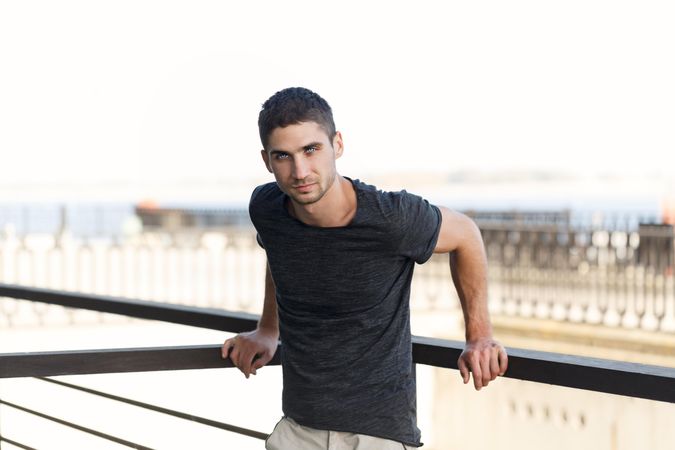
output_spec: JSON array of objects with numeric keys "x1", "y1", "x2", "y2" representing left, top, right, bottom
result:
[{"x1": 288, "y1": 175, "x2": 356, "y2": 227}]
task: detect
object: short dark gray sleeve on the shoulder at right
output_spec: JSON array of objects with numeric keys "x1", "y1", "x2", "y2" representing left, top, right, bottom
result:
[{"x1": 398, "y1": 191, "x2": 441, "y2": 264}]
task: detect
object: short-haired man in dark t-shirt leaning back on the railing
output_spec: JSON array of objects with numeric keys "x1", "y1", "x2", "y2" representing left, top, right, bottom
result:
[{"x1": 222, "y1": 88, "x2": 507, "y2": 450}]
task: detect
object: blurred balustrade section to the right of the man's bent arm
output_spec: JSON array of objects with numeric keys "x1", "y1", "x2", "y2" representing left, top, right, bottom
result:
[{"x1": 481, "y1": 222, "x2": 675, "y2": 333}]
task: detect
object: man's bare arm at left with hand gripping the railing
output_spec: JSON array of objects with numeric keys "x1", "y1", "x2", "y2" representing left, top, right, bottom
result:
[{"x1": 222, "y1": 263, "x2": 279, "y2": 378}]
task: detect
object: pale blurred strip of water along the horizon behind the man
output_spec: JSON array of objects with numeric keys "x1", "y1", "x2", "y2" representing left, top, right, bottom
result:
[{"x1": 0, "y1": 180, "x2": 667, "y2": 238}]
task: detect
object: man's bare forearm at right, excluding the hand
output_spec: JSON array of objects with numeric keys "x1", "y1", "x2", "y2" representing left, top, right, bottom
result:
[{"x1": 450, "y1": 222, "x2": 492, "y2": 341}]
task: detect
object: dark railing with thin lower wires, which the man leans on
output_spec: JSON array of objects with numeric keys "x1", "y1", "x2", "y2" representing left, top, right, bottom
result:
[{"x1": 0, "y1": 284, "x2": 675, "y2": 448}]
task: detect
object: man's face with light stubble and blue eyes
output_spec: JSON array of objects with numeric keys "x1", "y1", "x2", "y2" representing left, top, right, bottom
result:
[{"x1": 262, "y1": 122, "x2": 342, "y2": 205}]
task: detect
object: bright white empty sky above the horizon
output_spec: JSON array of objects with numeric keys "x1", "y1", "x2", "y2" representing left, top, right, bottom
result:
[{"x1": 0, "y1": 0, "x2": 675, "y2": 183}]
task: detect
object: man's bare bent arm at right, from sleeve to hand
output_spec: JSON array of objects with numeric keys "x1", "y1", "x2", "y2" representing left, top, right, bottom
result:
[{"x1": 434, "y1": 207, "x2": 508, "y2": 390}]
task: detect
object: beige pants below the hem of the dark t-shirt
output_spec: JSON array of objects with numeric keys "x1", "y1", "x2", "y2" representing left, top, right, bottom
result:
[{"x1": 265, "y1": 417, "x2": 413, "y2": 450}]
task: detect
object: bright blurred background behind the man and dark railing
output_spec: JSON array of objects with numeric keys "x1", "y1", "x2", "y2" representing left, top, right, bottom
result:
[{"x1": 0, "y1": 0, "x2": 675, "y2": 449}]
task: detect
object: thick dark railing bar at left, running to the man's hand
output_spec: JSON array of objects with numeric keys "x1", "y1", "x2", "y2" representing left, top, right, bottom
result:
[{"x1": 0, "y1": 345, "x2": 280, "y2": 379}]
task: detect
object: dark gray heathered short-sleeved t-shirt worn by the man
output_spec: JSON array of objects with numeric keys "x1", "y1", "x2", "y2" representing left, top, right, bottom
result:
[{"x1": 249, "y1": 180, "x2": 441, "y2": 446}]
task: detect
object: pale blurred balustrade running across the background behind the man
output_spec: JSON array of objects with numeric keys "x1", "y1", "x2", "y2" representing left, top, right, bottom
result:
[{"x1": 0, "y1": 218, "x2": 675, "y2": 334}]
